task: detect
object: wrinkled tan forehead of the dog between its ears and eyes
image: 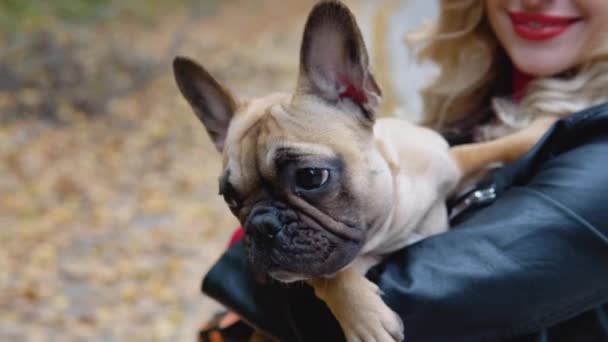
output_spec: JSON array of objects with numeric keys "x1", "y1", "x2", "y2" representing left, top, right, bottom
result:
[{"x1": 223, "y1": 95, "x2": 354, "y2": 193}]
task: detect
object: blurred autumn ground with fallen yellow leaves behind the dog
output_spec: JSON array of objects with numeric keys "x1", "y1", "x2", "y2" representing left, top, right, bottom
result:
[{"x1": 0, "y1": 0, "x2": 436, "y2": 341}]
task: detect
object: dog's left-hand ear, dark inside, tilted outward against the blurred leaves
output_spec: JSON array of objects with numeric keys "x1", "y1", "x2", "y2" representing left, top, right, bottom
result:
[{"x1": 173, "y1": 57, "x2": 236, "y2": 152}]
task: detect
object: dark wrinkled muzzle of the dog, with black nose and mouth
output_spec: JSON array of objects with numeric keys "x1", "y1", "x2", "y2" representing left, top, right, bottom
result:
[{"x1": 245, "y1": 200, "x2": 364, "y2": 282}]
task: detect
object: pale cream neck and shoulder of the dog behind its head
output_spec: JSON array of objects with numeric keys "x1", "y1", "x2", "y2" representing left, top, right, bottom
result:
[{"x1": 361, "y1": 119, "x2": 460, "y2": 255}]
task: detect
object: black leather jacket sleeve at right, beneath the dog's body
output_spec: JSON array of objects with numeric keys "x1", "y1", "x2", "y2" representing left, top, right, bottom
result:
[{"x1": 375, "y1": 135, "x2": 608, "y2": 341}]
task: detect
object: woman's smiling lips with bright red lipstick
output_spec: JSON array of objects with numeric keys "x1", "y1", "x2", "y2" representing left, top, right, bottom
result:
[{"x1": 509, "y1": 12, "x2": 580, "y2": 41}]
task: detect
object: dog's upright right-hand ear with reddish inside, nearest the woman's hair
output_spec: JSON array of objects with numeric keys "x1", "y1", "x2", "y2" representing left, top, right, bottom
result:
[{"x1": 296, "y1": 1, "x2": 382, "y2": 120}]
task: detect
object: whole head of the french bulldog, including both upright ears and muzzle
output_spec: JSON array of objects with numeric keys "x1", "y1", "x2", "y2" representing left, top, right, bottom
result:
[{"x1": 173, "y1": 1, "x2": 391, "y2": 281}]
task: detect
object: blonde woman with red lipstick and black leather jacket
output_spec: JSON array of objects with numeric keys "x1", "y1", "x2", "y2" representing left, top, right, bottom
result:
[{"x1": 203, "y1": 0, "x2": 608, "y2": 341}]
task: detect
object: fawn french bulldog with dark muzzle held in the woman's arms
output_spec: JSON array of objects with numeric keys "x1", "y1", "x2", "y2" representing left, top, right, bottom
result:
[{"x1": 173, "y1": 1, "x2": 549, "y2": 341}]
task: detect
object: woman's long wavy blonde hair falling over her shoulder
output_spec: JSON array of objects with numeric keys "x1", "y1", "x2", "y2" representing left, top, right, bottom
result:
[{"x1": 416, "y1": 0, "x2": 608, "y2": 140}]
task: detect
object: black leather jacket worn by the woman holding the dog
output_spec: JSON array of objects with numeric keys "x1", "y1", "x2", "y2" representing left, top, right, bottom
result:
[{"x1": 203, "y1": 104, "x2": 608, "y2": 342}]
